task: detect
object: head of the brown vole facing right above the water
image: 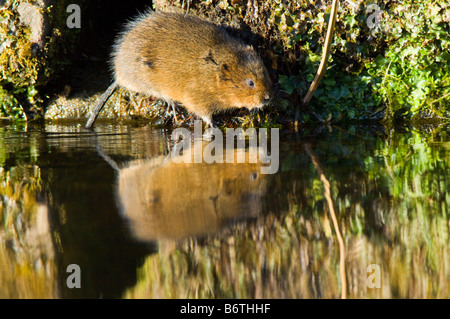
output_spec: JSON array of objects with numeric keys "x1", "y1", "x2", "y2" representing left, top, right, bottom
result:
[{"x1": 213, "y1": 45, "x2": 272, "y2": 110}]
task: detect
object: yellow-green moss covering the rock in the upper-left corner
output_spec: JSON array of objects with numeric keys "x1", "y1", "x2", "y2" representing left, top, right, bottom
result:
[{"x1": 0, "y1": 0, "x2": 88, "y2": 119}]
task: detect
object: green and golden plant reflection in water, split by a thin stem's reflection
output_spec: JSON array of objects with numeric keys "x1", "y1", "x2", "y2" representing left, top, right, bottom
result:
[{"x1": 125, "y1": 128, "x2": 450, "y2": 298}]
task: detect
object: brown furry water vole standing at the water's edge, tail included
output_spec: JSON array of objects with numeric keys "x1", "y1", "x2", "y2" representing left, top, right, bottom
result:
[{"x1": 86, "y1": 12, "x2": 272, "y2": 128}]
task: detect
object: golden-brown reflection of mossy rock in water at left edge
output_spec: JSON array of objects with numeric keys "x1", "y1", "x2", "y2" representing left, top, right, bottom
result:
[{"x1": 0, "y1": 166, "x2": 56, "y2": 298}]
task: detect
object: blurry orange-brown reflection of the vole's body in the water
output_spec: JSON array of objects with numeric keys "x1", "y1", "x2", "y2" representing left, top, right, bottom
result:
[{"x1": 118, "y1": 151, "x2": 268, "y2": 241}]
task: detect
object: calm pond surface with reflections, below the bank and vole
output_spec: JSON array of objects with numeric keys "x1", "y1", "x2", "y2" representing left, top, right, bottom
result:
[{"x1": 0, "y1": 122, "x2": 450, "y2": 298}]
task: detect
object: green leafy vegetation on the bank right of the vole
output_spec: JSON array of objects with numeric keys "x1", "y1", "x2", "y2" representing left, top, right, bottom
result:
[{"x1": 280, "y1": 1, "x2": 450, "y2": 120}]
